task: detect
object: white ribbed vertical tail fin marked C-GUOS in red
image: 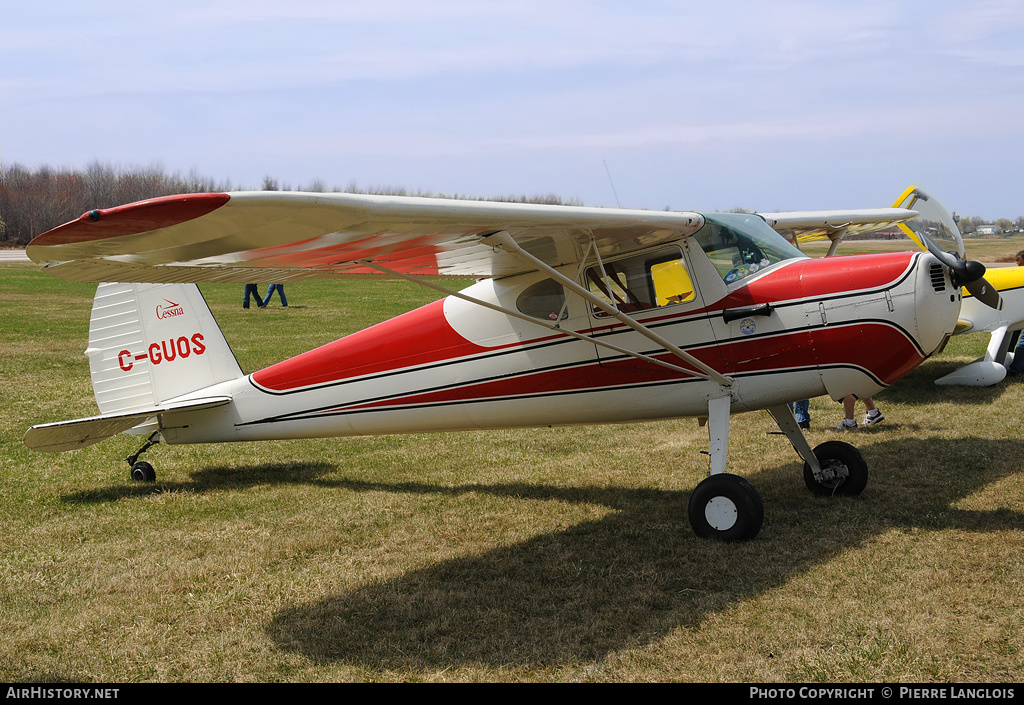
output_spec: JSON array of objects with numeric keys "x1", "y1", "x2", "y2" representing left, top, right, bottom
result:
[{"x1": 85, "y1": 284, "x2": 242, "y2": 414}]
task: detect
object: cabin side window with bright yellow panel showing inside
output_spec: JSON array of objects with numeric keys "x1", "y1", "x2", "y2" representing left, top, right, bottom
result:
[{"x1": 587, "y1": 249, "x2": 695, "y2": 318}]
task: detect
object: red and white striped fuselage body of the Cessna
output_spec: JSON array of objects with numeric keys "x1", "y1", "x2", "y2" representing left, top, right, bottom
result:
[{"x1": 162, "y1": 248, "x2": 959, "y2": 444}]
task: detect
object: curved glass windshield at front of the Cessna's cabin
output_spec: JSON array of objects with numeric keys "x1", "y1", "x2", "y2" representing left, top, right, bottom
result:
[{"x1": 693, "y1": 213, "x2": 807, "y2": 284}]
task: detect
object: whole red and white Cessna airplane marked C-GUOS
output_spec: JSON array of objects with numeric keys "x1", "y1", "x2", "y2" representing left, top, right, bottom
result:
[{"x1": 25, "y1": 185, "x2": 998, "y2": 540}]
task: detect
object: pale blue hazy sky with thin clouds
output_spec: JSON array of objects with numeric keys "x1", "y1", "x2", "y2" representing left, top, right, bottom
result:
[{"x1": 0, "y1": 0, "x2": 1024, "y2": 218}]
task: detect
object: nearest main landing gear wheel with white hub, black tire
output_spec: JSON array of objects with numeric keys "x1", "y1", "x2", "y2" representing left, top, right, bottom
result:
[{"x1": 689, "y1": 472, "x2": 765, "y2": 541}]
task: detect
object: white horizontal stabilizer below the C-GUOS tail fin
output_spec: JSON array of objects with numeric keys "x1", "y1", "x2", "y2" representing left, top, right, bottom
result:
[{"x1": 25, "y1": 397, "x2": 231, "y2": 453}]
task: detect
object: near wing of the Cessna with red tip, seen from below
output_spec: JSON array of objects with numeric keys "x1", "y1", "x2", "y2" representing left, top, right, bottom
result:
[{"x1": 27, "y1": 192, "x2": 703, "y2": 283}]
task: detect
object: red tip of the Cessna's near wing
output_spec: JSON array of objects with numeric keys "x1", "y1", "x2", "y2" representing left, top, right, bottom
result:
[{"x1": 29, "y1": 194, "x2": 231, "y2": 247}]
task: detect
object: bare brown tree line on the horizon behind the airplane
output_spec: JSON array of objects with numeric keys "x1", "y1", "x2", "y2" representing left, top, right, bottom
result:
[{"x1": 0, "y1": 162, "x2": 1024, "y2": 247}]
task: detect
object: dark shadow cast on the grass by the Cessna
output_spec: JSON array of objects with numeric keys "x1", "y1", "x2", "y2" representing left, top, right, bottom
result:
[{"x1": 266, "y1": 439, "x2": 1024, "y2": 669}]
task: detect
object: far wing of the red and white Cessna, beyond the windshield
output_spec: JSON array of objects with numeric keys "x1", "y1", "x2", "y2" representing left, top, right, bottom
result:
[{"x1": 758, "y1": 208, "x2": 918, "y2": 254}]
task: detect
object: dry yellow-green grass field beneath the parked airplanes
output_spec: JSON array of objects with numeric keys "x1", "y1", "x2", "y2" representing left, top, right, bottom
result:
[{"x1": 0, "y1": 257, "x2": 1024, "y2": 682}]
